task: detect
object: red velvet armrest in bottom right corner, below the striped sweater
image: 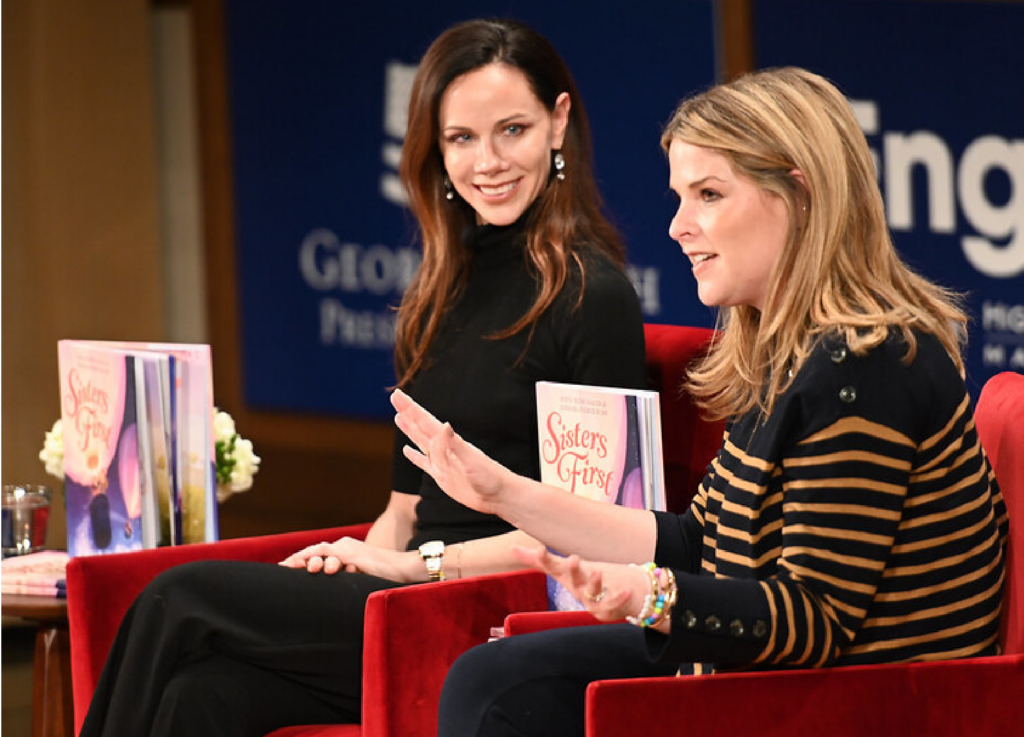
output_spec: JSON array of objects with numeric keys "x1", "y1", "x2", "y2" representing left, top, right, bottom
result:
[{"x1": 587, "y1": 655, "x2": 1024, "y2": 737}]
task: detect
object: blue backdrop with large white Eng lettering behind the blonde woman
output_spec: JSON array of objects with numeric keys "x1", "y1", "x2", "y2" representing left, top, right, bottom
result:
[{"x1": 755, "y1": 0, "x2": 1024, "y2": 395}]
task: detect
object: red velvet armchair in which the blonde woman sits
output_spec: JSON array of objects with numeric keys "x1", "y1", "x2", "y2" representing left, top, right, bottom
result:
[{"x1": 505, "y1": 372, "x2": 1024, "y2": 737}]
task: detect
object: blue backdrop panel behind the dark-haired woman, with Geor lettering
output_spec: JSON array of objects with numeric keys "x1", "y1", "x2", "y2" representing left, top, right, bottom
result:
[{"x1": 227, "y1": 0, "x2": 714, "y2": 417}]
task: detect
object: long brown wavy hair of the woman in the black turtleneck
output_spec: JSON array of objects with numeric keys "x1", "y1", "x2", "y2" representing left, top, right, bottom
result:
[{"x1": 395, "y1": 19, "x2": 625, "y2": 386}]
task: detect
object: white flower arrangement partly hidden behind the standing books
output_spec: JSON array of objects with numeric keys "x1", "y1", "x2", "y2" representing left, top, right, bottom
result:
[{"x1": 39, "y1": 407, "x2": 260, "y2": 502}]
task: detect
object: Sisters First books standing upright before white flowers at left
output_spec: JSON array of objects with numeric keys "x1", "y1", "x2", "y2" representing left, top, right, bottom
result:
[{"x1": 58, "y1": 340, "x2": 217, "y2": 556}]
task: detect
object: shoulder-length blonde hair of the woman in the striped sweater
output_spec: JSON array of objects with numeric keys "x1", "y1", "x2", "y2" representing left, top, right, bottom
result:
[{"x1": 662, "y1": 68, "x2": 967, "y2": 419}]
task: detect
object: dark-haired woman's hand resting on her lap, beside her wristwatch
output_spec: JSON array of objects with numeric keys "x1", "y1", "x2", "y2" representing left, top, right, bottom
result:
[{"x1": 279, "y1": 537, "x2": 426, "y2": 583}]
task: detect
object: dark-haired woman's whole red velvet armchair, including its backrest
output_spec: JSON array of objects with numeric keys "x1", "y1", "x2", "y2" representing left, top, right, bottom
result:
[{"x1": 68, "y1": 326, "x2": 723, "y2": 737}]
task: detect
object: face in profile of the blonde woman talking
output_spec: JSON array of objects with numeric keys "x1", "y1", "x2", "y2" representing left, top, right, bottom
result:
[{"x1": 669, "y1": 140, "x2": 790, "y2": 310}]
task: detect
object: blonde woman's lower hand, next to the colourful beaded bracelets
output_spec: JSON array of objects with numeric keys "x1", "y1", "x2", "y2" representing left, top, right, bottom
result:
[{"x1": 513, "y1": 547, "x2": 650, "y2": 621}]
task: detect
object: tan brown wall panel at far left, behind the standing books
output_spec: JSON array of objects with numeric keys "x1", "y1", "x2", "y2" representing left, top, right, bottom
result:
[{"x1": 0, "y1": 0, "x2": 163, "y2": 544}]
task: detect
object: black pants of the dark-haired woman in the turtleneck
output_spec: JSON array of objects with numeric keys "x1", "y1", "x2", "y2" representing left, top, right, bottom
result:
[{"x1": 81, "y1": 561, "x2": 396, "y2": 737}]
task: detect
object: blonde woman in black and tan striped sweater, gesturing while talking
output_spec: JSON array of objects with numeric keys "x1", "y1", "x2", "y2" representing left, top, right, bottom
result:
[{"x1": 393, "y1": 69, "x2": 1007, "y2": 737}]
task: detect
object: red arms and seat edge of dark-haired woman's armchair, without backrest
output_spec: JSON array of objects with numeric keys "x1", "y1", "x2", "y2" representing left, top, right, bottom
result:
[{"x1": 68, "y1": 524, "x2": 547, "y2": 737}]
